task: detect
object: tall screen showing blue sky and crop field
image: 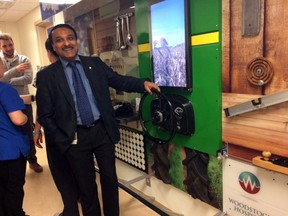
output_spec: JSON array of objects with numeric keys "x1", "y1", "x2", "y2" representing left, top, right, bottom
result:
[{"x1": 150, "y1": 0, "x2": 192, "y2": 91}]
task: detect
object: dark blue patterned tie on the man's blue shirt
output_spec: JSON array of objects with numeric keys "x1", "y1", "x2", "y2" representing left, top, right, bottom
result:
[{"x1": 68, "y1": 61, "x2": 94, "y2": 125}]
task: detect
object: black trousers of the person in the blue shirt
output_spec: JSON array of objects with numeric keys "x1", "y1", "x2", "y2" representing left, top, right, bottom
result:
[{"x1": 0, "y1": 156, "x2": 26, "y2": 216}]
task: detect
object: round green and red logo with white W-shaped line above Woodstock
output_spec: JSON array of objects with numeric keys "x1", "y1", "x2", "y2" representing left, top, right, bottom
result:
[{"x1": 238, "y1": 172, "x2": 261, "y2": 194}]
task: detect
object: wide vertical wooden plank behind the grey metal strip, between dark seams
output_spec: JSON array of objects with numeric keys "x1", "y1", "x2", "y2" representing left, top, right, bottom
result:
[{"x1": 230, "y1": 0, "x2": 264, "y2": 94}]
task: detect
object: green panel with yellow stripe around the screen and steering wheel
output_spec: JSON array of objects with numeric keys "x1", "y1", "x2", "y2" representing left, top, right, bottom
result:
[{"x1": 135, "y1": 0, "x2": 222, "y2": 155}]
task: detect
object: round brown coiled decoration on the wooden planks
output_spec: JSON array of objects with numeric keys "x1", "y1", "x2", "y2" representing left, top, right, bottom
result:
[{"x1": 246, "y1": 57, "x2": 274, "y2": 86}]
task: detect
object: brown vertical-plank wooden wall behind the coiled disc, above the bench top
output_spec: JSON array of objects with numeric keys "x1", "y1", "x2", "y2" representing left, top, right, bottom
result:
[{"x1": 222, "y1": 0, "x2": 288, "y2": 95}]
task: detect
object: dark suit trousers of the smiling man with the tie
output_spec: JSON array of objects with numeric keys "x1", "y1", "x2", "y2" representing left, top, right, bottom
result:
[{"x1": 66, "y1": 120, "x2": 119, "y2": 216}]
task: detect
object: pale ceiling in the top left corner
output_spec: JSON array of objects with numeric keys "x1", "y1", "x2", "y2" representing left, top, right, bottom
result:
[{"x1": 0, "y1": 0, "x2": 39, "y2": 22}]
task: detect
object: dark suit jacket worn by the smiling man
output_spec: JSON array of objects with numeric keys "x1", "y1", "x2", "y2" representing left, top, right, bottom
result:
[{"x1": 36, "y1": 56, "x2": 145, "y2": 152}]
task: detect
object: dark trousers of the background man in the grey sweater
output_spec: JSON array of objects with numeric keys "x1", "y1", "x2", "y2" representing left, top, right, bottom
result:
[{"x1": 24, "y1": 104, "x2": 37, "y2": 164}]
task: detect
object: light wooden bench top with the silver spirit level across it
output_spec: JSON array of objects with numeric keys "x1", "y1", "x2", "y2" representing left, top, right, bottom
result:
[{"x1": 222, "y1": 93, "x2": 288, "y2": 157}]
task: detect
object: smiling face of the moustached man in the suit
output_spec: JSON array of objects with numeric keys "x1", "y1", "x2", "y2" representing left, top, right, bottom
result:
[{"x1": 51, "y1": 27, "x2": 78, "y2": 62}]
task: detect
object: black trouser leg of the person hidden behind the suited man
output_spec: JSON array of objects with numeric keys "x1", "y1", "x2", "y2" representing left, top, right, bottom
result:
[{"x1": 46, "y1": 143, "x2": 79, "y2": 216}]
